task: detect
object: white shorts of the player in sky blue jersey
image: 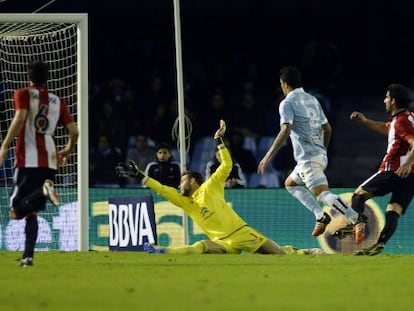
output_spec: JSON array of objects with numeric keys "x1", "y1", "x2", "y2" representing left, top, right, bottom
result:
[{"x1": 290, "y1": 155, "x2": 328, "y2": 189}]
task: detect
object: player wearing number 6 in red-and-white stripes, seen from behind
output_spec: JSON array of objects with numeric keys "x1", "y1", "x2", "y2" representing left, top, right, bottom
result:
[{"x1": 0, "y1": 61, "x2": 79, "y2": 267}]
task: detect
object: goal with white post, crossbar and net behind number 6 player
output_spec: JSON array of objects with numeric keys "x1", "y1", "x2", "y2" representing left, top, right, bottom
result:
[{"x1": 0, "y1": 14, "x2": 89, "y2": 251}]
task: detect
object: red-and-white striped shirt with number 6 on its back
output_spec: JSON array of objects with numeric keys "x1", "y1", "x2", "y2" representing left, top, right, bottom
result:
[{"x1": 13, "y1": 86, "x2": 73, "y2": 169}]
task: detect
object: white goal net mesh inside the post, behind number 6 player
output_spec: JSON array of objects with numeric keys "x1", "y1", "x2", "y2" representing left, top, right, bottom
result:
[{"x1": 0, "y1": 22, "x2": 78, "y2": 250}]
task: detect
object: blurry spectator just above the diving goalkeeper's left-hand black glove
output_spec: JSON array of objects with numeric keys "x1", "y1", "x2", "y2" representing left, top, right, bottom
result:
[{"x1": 126, "y1": 134, "x2": 157, "y2": 184}]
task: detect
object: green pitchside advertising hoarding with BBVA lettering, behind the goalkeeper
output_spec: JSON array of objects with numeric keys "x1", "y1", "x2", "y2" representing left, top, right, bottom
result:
[{"x1": 0, "y1": 188, "x2": 414, "y2": 254}]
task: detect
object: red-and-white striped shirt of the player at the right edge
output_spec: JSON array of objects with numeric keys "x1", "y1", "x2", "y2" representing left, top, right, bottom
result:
[{"x1": 380, "y1": 110, "x2": 414, "y2": 173}]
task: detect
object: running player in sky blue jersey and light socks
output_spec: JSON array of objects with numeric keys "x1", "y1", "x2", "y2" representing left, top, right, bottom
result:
[{"x1": 257, "y1": 67, "x2": 366, "y2": 244}]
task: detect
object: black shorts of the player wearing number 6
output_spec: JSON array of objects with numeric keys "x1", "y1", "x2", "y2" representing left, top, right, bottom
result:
[{"x1": 10, "y1": 167, "x2": 56, "y2": 219}]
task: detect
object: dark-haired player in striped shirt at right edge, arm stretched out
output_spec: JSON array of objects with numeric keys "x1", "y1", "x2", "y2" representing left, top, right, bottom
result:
[{"x1": 333, "y1": 84, "x2": 414, "y2": 256}]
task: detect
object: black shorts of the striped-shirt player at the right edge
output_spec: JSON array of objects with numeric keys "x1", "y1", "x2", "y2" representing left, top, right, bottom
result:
[{"x1": 360, "y1": 172, "x2": 414, "y2": 213}]
